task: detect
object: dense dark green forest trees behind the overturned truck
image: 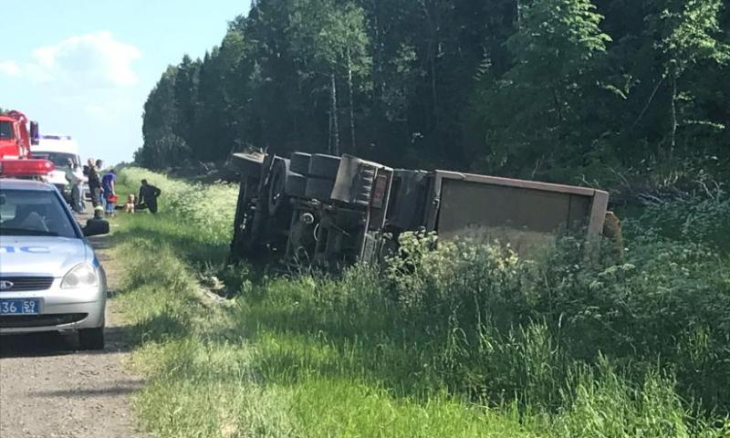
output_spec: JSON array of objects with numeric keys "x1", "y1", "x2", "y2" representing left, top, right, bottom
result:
[{"x1": 136, "y1": 0, "x2": 730, "y2": 183}]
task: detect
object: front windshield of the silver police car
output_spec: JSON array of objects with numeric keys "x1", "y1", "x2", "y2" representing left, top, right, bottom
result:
[{"x1": 0, "y1": 188, "x2": 78, "y2": 238}]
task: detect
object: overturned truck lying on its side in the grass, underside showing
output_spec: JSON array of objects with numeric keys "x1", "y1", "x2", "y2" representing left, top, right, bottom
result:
[{"x1": 230, "y1": 152, "x2": 620, "y2": 270}]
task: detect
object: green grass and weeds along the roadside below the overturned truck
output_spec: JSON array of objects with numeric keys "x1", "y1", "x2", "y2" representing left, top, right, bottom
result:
[{"x1": 114, "y1": 168, "x2": 730, "y2": 438}]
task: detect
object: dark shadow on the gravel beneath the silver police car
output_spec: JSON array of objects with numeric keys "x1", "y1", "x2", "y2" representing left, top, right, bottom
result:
[{"x1": 0, "y1": 326, "x2": 130, "y2": 360}]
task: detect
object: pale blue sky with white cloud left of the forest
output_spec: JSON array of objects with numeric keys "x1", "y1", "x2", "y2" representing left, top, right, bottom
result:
[{"x1": 0, "y1": 0, "x2": 250, "y2": 164}]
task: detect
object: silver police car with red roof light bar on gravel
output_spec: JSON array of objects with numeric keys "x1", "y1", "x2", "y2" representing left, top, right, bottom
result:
[{"x1": 0, "y1": 160, "x2": 109, "y2": 349}]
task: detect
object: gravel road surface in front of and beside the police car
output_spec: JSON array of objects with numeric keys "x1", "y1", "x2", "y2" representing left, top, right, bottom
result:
[{"x1": 0, "y1": 231, "x2": 142, "y2": 438}]
